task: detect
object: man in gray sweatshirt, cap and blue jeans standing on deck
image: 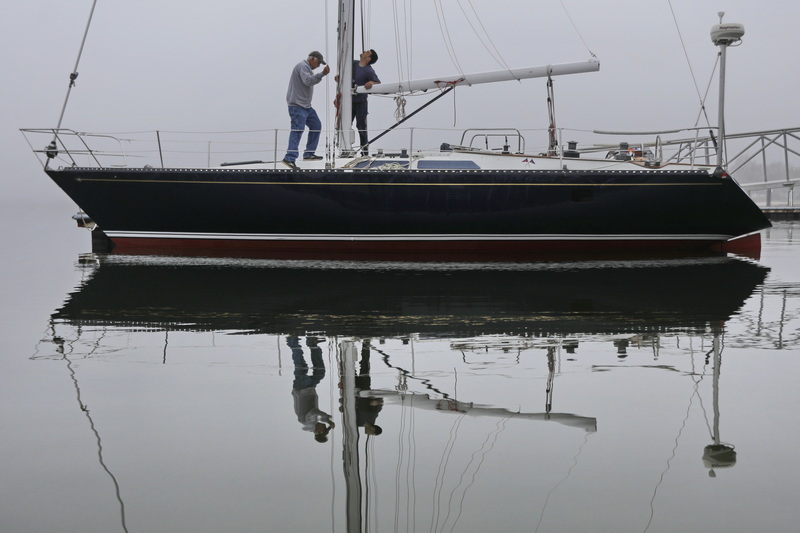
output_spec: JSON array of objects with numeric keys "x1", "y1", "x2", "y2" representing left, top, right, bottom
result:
[{"x1": 283, "y1": 51, "x2": 331, "y2": 169}]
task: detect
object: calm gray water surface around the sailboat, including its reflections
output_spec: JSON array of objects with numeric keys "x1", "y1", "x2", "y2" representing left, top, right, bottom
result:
[{"x1": 0, "y1": 205, "x2": 800, "y2": 533}]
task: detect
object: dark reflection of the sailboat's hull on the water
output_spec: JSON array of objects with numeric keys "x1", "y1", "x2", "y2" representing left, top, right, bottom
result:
[{"x1": 53, "y1": 251, "x2": 768, "y2": 337}]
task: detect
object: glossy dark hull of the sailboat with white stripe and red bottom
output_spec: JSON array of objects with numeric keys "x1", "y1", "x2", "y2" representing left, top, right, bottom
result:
[{"x1": 47, "y1": 168, "x2": 770, "y2": 259}]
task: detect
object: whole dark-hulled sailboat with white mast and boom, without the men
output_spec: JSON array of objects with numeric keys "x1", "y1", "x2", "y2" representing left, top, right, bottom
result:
[{"x1": 23, "y1": 0, "x2": 770, "y2": 261}]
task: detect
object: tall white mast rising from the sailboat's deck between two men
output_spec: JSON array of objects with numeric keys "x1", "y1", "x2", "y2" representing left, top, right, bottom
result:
[{"x1": 336, "y1": 0, "x2": 355, "y2": 153}]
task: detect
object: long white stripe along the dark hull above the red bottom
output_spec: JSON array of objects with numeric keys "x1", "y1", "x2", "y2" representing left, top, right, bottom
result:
[{"x1": 106, "y1": 231, "x2": 732, "y2": 241}]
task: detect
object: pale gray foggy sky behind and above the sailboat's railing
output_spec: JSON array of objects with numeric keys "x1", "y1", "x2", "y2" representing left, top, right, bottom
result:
[{"x1": 0, "y1": 0, "x2": 800, "y2": 202}]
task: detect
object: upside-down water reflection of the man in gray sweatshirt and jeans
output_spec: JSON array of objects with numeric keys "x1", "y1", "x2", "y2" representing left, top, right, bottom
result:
[{"x1": 286, "y1": 336, "x2": 335, "y2": 442}]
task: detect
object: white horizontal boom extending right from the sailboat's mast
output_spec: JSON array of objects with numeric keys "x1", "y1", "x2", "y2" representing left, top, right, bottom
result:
[{"x1": 356, "y1": 58, "x2": 600, "y2": 94}]
